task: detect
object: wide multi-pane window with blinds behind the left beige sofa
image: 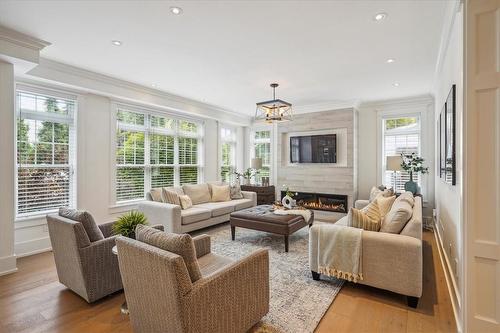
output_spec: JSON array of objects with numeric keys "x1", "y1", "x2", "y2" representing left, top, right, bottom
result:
[{"x1": 116, "y1": 107, "x2": 201, "y2": 202}]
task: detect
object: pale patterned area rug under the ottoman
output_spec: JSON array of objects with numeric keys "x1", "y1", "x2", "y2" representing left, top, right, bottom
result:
[{"x1": 192, "y1": 224, "x2": 343, "y2": 333}]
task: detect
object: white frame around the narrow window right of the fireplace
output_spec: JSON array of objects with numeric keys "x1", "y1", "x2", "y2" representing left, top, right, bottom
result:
[{"x1": 374, "y1": 107, "x2": 432, "y2": 198}]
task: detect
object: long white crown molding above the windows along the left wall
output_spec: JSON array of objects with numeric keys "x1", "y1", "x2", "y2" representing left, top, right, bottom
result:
[{"x1": 27, "y1": 58, "x2": 252, "y2": 126}]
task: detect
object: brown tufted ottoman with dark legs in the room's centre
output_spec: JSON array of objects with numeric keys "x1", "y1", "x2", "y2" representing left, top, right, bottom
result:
[{"x1": 229, "y1": 205, "x2": 314, "y2": 252}]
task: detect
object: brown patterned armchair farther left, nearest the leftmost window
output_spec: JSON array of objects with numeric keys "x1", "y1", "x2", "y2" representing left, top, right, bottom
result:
[{"x1": 47, "y1": 213, "x2": 123, "y2": 303}]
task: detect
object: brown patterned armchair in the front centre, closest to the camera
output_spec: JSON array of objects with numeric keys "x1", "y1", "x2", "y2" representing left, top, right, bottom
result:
[{"x1": 116, "y1": 231, "x2": 269, "y2": 333}]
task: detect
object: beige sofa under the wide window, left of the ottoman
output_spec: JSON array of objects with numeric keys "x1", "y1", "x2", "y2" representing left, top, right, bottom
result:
[{"x1": 138, "y1": 183, "x2": 257, "y2": 233}]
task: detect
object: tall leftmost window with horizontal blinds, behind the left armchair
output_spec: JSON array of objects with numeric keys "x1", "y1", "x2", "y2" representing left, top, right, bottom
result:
[{"x1": 16, "y1": 89, "x2": 76, "y2": 217}]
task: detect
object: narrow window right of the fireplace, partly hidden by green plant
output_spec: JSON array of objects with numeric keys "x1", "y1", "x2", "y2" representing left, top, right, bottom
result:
[{"x1": 382, "y1": 116, "x2": 421, "y2": 192}]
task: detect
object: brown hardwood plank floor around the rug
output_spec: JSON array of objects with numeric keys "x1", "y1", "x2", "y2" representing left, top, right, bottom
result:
[{"x1": 0, "y1": 232, "x2": 456, "y2": 333}]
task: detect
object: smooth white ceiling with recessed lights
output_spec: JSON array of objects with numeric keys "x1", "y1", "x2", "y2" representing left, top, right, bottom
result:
[{"x1": 0, "y1": 0, "x2": 446, "y2": 115}]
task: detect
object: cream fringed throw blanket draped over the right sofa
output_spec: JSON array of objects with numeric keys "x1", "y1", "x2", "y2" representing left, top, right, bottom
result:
[{"x1": 318, "y1": 224, "x2": 363, "y2": 282}]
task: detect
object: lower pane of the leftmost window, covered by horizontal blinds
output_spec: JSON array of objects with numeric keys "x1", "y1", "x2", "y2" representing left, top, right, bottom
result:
[{"x1": 17, "y1": 167, "x2": 70, "y2": 214}]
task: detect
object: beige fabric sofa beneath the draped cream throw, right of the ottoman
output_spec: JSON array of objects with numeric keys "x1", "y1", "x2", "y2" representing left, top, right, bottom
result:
[{"x1": 309, "y1": 197, "x2": 422, "y2": 307}]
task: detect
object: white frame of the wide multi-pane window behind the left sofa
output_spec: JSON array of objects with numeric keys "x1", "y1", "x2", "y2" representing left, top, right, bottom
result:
[{"x1": 110, "y1": 101, "x2": 205, "y2": 208}]
